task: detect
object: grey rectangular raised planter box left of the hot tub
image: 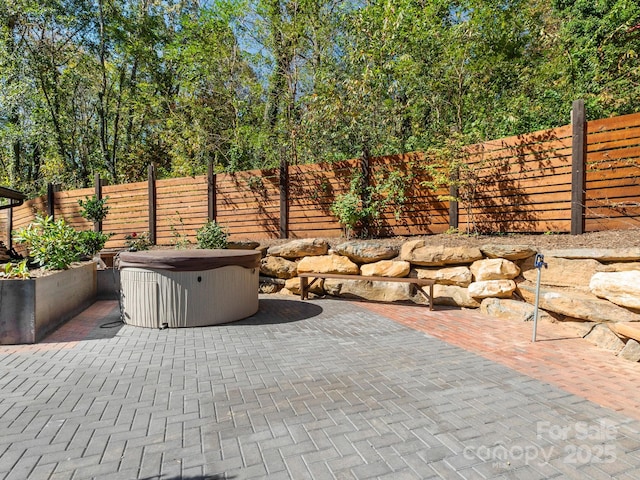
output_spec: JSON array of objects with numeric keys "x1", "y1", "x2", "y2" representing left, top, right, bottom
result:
[{"x1": 0, "y1": 262, "x2": 97, "y2": 345}]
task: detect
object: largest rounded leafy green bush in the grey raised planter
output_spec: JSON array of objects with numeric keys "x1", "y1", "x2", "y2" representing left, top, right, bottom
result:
[{"x1": 14, "y1": 213, "x2": 84, "y2": 270}]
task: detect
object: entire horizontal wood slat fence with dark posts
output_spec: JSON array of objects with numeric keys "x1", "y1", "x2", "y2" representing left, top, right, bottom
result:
[{"x1": 0, "y1": 100, "x2": 640, "y2": 248}]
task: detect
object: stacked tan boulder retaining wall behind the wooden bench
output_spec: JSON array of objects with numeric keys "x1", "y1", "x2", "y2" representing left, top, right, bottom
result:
[{"x1": 260, "y1": 239, "x2": 640, "y2": 362}]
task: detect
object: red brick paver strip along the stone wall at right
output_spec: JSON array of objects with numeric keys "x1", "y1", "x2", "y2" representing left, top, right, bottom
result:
[{"x1": 360, "y1": 302, "x2": 640, "y2": 419}]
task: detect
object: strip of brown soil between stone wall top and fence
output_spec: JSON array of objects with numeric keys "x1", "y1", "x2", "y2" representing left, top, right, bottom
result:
[{"x1": 254, "y1": 228, "x2": 640, "y2": 250}]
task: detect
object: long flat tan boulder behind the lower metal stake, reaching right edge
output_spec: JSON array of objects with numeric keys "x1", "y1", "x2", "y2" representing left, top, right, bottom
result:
[{"x1": 518, "y1": 282, "x2": 640, "y2": 323}]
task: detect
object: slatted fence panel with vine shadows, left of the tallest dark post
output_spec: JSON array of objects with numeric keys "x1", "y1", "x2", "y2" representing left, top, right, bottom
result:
[{"x1": 460, "y1": 126, "x2": 572, "y2": 233}]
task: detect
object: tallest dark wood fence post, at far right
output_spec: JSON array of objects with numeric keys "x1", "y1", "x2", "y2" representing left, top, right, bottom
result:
[{"x1": 571, "y1": 100, "x2": 587, "y2": 235}]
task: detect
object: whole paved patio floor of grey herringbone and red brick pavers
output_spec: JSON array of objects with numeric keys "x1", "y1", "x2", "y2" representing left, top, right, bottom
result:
[{"x1": 0, "y1": 296, "x2": 640, "y2": 480}]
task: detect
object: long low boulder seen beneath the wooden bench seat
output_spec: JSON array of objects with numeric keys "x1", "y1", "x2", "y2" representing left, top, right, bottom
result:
[{"x1": 324, "y1": 278, "x2": 424, "y2": 303}]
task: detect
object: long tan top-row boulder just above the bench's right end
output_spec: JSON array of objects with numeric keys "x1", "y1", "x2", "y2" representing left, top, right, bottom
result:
[{"x1": 400, "y1": 240, "x2": 482, "y2": 267}]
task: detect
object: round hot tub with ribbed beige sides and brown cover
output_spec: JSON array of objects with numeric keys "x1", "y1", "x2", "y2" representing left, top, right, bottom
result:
[{"x1": 119, "y1": 250, "x2": 261, "y2": 328}]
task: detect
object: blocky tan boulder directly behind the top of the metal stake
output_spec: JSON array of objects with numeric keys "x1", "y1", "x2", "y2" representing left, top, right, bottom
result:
[{"x1": 522, "y1": 256, "x2": 601, "y2": 288}]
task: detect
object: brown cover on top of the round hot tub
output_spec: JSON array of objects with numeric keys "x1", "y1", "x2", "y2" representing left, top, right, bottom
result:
[{"x1": 120, "y1": 249, "x2": 262, "y2": 272}]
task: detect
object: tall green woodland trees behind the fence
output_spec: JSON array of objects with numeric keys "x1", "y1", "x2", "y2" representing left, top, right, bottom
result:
[{"x1": 0, "y1": 0, "x2": 640, "y2": 194}]
